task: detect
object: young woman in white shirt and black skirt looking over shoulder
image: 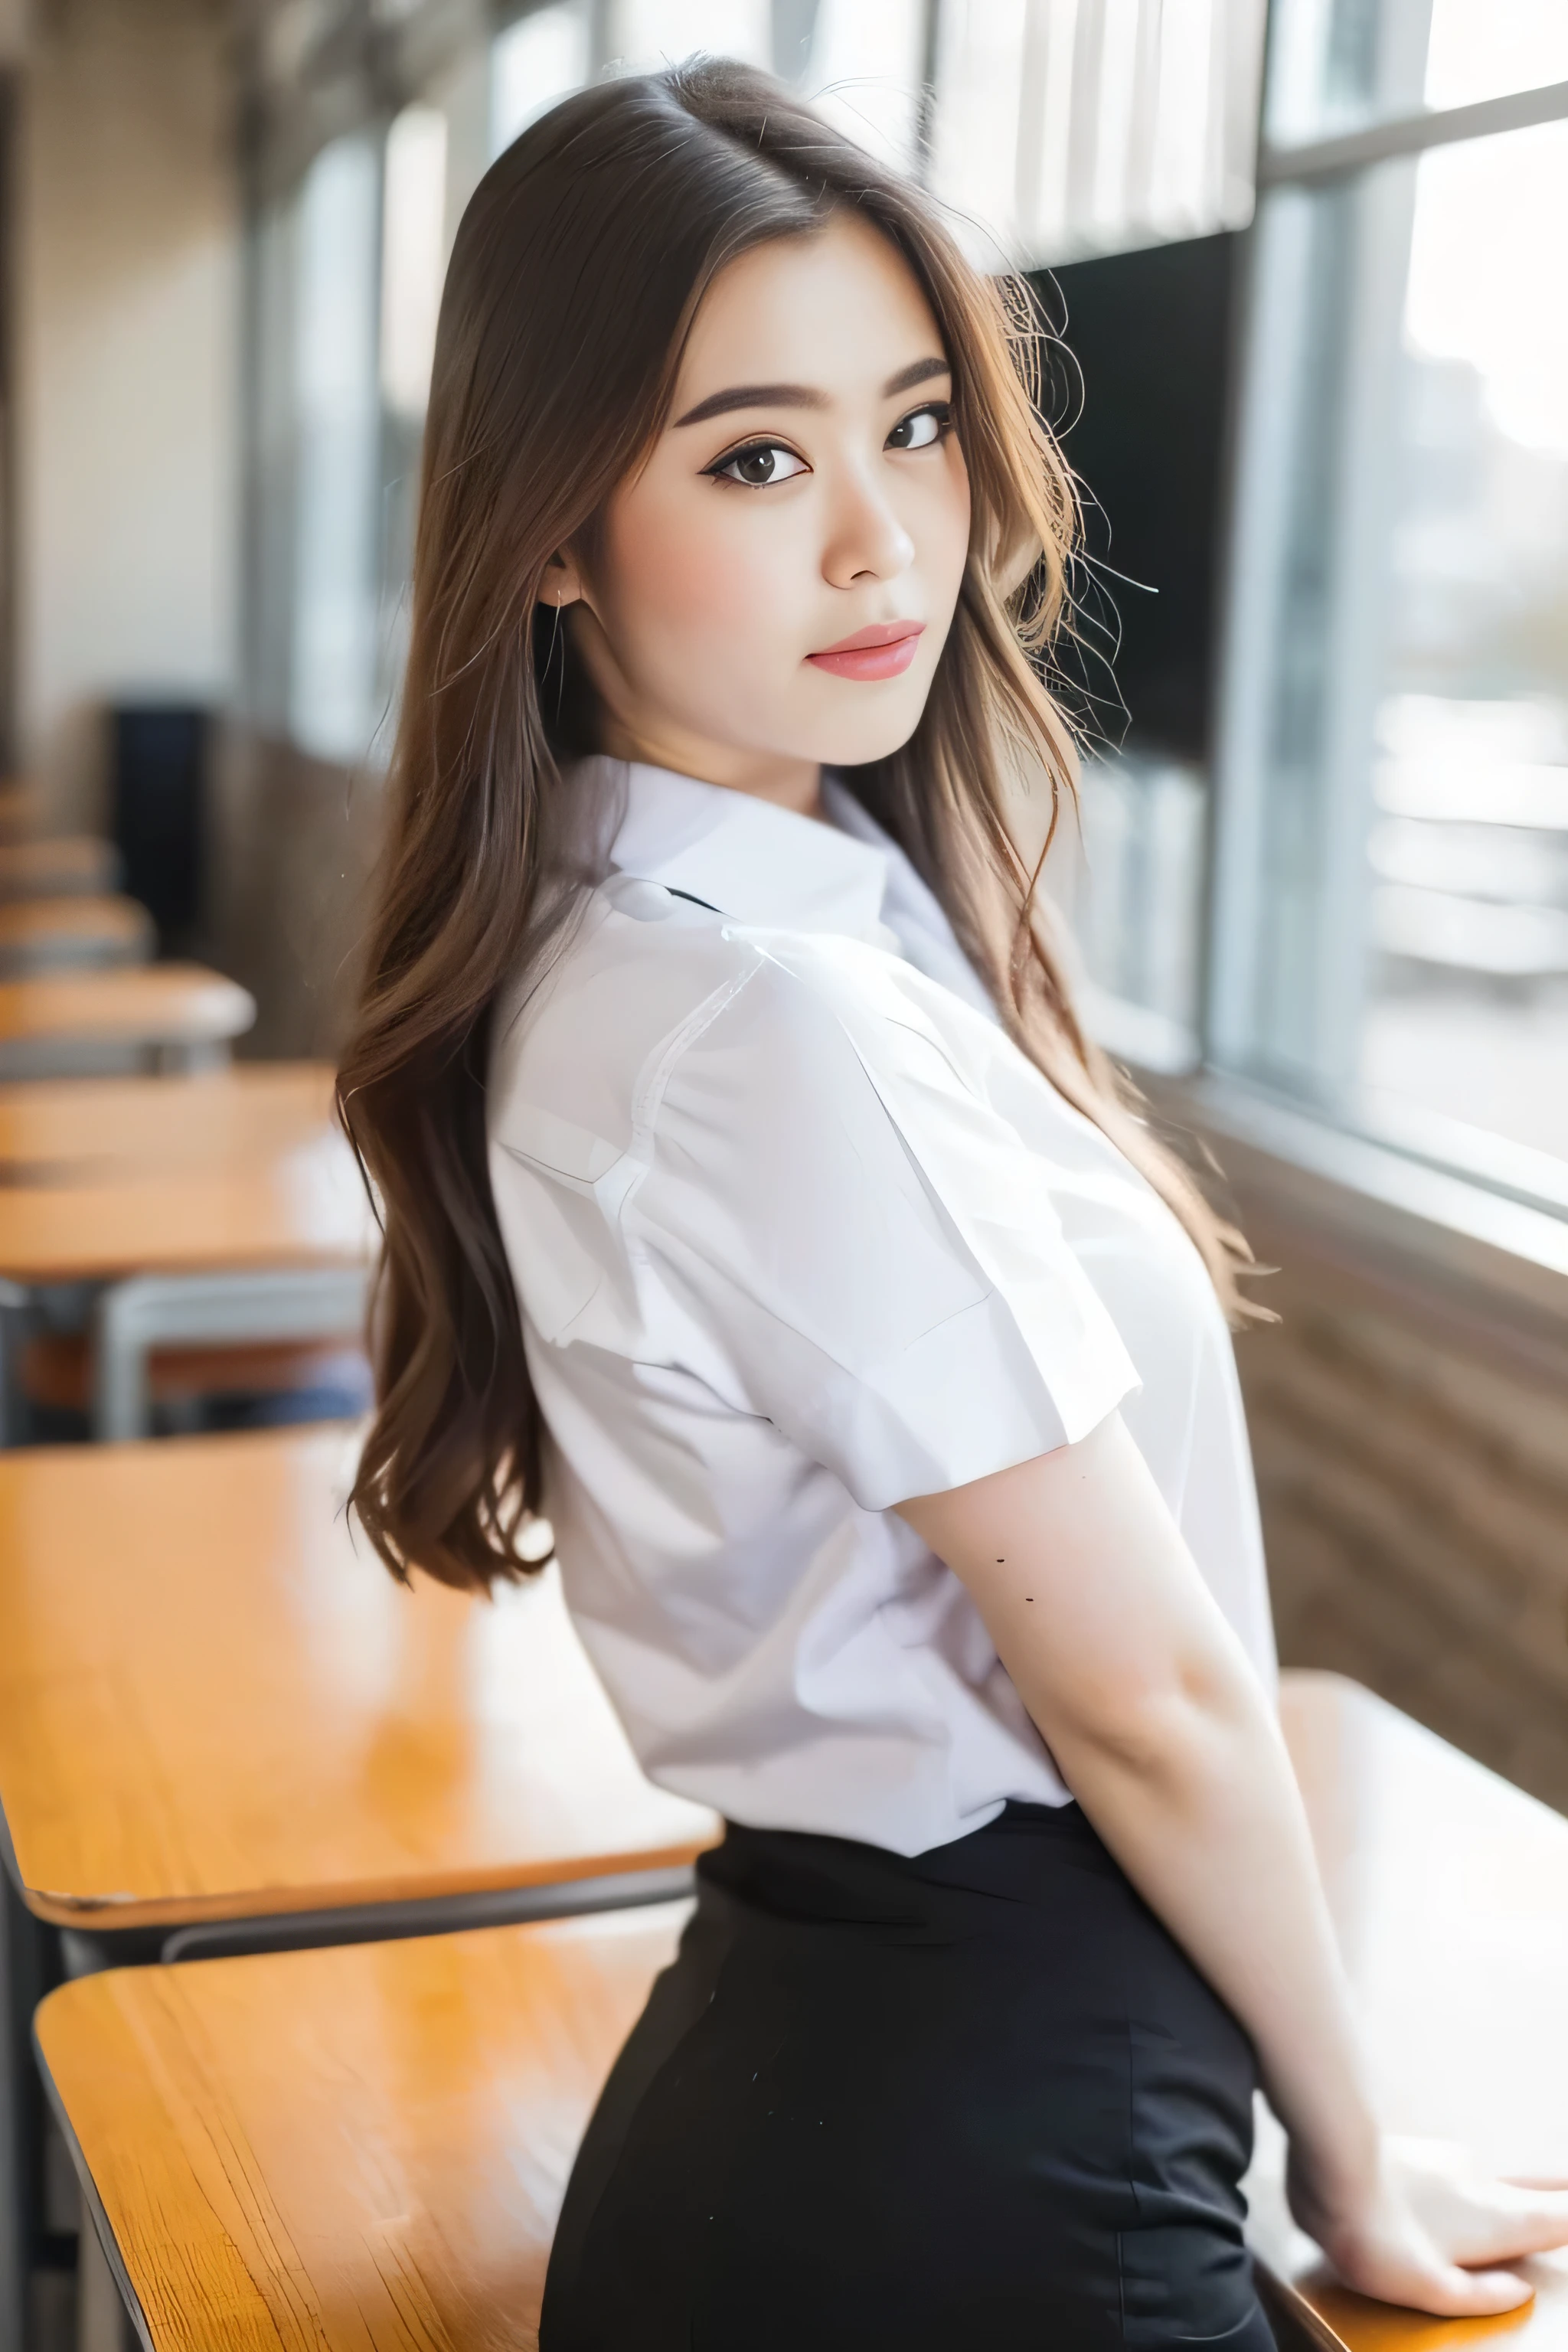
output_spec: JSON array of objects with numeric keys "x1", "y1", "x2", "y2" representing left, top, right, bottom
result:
[{"x1": 341, "y1": 64, "x2": 1568, "y2": 2352}]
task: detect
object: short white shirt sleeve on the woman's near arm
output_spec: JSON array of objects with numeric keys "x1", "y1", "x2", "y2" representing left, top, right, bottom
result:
[{"x1": 628, "y1": 962, "x2": 1138, "y2": 1510}]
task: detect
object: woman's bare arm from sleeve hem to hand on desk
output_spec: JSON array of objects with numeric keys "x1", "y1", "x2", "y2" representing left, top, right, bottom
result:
[{"x1": 900, "y1": 1413, "x2": 1568, "y2": 2312}]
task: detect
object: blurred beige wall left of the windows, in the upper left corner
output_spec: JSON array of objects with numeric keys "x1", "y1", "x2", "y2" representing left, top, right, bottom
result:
[{"x1": 16, "y1": 0, "x2": 240, "y2": 823}]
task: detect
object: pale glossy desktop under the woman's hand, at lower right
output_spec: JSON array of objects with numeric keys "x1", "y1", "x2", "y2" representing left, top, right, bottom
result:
[{"x1": 1253, "y1": 1674, "x2": 1568, "y2": 2352}]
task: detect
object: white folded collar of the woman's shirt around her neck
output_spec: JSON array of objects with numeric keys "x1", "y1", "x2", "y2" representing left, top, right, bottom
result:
[{"x1": 609, "y1": 760, "x2": 889, "y2": 946}]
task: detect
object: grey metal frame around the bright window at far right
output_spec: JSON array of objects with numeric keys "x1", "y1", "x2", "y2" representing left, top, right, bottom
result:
[{"x1": 1194, "y1": 32, "x2": 1568, "y2": 1325}]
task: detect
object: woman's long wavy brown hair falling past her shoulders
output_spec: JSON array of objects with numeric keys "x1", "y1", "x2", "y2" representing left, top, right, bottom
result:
[{"x1": 338, "y1": 61, "x2": 1243, "y2": 1586}]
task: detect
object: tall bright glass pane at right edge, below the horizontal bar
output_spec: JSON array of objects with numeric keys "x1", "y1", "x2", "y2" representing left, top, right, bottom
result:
[{"x1": 1361, "y1": 122, "x2": 1568, "y2": 1159}]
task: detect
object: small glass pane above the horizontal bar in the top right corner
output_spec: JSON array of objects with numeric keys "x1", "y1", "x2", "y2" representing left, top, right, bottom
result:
[{"x1": 1267, "y1": 0, "x2": 1568, "y2": 145}]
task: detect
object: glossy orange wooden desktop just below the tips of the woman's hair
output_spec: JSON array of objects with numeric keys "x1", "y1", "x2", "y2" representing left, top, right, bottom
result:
[{"x1": 0, "y1": 1428, "x2": 712, "y2": 1929}]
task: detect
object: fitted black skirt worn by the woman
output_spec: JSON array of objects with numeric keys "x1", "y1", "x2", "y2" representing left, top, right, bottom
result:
[{"x1": 538, "y1": 1804, "x2": 1274, "y2": 2352}]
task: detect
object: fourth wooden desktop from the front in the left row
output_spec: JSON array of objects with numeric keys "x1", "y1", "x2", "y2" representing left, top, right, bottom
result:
[{"x1": 0, "y1": 1060, "x2": 334, "y2": 1183}]
